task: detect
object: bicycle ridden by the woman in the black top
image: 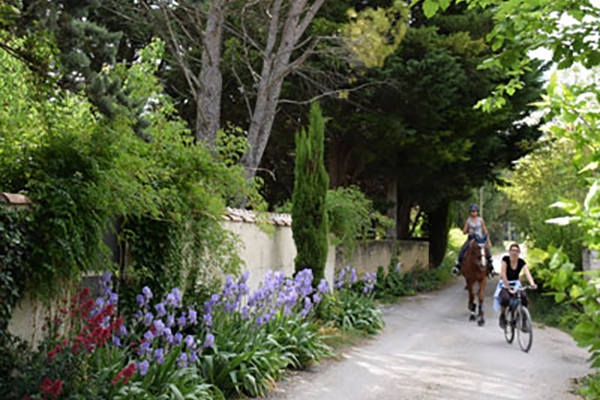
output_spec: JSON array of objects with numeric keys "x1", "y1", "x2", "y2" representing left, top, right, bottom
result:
[{"x1": 504, "y1": 286, "x2": 533, "y2": 353}]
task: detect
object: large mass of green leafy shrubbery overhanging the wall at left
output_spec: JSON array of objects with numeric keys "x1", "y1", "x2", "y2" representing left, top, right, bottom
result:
[{"x1": 0, "y1": 42, "x2": 261, "y2": 303}]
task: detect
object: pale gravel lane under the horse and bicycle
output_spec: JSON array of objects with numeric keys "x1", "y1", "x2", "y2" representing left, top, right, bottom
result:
[{"x1": 269, "y1": 262, "x2": 588, "y2": 400}]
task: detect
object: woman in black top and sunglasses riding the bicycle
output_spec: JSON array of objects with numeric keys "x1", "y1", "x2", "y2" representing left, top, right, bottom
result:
[{"x1": 494, "y1": 243, "x2": 537, "y2": 329}]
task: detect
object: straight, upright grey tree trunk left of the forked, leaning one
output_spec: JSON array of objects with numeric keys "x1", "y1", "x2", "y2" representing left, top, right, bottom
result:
[{"x1": 196, "y1": 0, "x2": 226, "y2": 146}]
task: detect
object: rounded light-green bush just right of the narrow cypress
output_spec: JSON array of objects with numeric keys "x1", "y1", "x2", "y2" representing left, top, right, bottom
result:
[{"x1": 327, "y1": 186, "x2": 392, "y2": 256}]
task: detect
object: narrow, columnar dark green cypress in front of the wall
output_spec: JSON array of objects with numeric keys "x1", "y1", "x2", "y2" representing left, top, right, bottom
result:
[{"x1": 292, "y1": 103, "x2": 329, "y2": 284}]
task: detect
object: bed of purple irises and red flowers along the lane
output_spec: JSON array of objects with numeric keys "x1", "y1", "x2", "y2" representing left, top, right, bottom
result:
[{"x1": 0, "y1": 267, "x2": 383, "y2": 400}]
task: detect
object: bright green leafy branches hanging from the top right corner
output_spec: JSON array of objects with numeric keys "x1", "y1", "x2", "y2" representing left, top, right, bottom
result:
[{"x1": 413, "y1": 0, "x2": 600, "y2": 111}]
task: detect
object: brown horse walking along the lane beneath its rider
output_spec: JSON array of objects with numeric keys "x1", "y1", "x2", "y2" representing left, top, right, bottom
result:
[{"x1": 461, "y1": 239, "x2": 487, "y2": 326}]
